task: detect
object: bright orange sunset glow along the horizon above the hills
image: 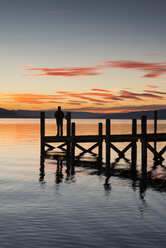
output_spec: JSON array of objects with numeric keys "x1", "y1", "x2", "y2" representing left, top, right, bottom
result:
[{"x1": 0, "y1": 85, "x2": 166, "y2": 113}]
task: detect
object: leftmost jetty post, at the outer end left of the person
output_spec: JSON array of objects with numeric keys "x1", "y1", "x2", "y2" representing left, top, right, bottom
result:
[{"x1": 40, "y1": 112, "x2": 45, "y2": 165}]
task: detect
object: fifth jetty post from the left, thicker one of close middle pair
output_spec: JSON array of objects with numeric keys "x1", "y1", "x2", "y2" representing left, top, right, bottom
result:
[{"x1": 106, "y1": 119, "x2": 110, "y2": 174}]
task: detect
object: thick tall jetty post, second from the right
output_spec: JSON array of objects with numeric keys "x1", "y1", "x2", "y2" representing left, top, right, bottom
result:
[{"x1": 141, "y1": 115, "x2": 147, "y2": 177}]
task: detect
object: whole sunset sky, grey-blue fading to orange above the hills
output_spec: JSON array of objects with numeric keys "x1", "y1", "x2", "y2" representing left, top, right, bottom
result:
[{"x1": 0, "y1": 0, "x2": 166, "y2": 113}]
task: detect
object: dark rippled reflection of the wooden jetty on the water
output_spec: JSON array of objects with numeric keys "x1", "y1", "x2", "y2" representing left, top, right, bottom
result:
[{"x1": 39, "y1": 153, "x2": 166, "y2": 200}]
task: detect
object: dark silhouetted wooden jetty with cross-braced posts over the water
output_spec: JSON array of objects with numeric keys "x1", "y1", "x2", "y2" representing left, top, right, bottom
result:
[{"x1": 40, "y1": 111, "x2": 166, "y2": 173}]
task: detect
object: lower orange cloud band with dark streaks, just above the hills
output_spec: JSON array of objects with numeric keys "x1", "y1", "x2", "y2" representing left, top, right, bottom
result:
[{"x1": 0, "y1": 89, "x2": 166, "y2": 111}]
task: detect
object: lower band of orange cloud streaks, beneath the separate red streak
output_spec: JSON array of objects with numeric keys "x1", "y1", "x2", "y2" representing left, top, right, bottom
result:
[{"x1": 1, "y1": 89, "x2": 166, "y2": 105}]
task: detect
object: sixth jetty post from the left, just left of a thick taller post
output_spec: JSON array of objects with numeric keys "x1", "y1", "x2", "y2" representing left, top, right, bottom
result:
[{"x1": 131, "y1": 119, "x2": 137, "y2": 170}]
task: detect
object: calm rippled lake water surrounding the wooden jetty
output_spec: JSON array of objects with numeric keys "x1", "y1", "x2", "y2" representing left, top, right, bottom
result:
[{"x1": 0, "y1": 119, "x2": 166, "y2": 248}]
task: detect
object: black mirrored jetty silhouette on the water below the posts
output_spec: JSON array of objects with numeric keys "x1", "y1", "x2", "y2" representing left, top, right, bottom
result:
[{"x1": 39, "y1": 156, "x2": 166, "y2": 202}]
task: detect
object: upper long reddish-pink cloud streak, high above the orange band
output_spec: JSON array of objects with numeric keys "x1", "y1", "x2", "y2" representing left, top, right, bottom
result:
[{"x1": 23, "y1": 60, "x2": 166, "y2": 78}]
